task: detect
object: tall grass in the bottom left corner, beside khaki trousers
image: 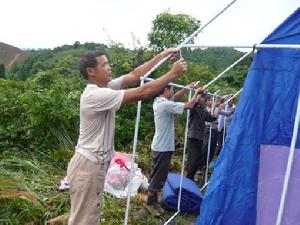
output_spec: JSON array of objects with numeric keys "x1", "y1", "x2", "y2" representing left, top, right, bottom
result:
[{"x1": 0, "y1": 154, "x2": 69, "y2": 225}]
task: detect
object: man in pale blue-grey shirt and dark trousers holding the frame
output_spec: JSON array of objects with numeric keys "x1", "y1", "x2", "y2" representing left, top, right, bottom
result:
[{"x1": 144, "y1": 83, "x2": 202, "y2": 216}]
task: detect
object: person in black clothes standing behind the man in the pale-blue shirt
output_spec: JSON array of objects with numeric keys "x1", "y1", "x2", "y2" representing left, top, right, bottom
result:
[{"x1": 186, "y1": 95, "x2": 217, "y2": 180}]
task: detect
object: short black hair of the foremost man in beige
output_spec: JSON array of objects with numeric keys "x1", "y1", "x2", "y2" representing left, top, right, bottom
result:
[{"x1": 79, "y1": 51, "x2": 104, "y2": 79}]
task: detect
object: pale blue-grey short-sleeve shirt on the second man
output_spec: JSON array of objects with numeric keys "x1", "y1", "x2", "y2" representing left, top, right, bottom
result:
[{"x1": 151, "y1": 97, "x2": 184, "y2": 152}]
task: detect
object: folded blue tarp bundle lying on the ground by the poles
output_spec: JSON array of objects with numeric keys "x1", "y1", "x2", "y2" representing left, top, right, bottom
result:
[{"x1": 163, "y1": 173, "x2": 202, "y2": 214}]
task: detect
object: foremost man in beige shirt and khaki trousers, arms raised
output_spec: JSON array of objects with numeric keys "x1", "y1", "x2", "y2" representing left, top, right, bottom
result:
[{"x1": 67, "y1": 49, "x2": 187, "y2": 225}]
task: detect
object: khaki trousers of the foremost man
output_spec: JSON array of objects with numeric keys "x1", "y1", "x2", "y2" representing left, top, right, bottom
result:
[{"x1": 67, "y1": 152, "x2": 109, "y2": 225}]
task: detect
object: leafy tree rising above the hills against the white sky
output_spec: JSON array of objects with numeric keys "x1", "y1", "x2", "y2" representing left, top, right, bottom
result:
[{"x1": 148, "y1": 11, "x2": 200, "y2": 51}]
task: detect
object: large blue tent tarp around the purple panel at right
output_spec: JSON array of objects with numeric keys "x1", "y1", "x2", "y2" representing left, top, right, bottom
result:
[{"x1": 195, "y1": 8, "x2": 300, "y2": 225}]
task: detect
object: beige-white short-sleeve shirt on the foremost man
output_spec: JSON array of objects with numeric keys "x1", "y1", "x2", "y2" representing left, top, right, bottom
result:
[{"x1": 76, "y1": 77, "x2": 124, "y2": 163}]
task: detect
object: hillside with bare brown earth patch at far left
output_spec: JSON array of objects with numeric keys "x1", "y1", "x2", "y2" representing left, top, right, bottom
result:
[{"x1": 0, "y1": 42, "x2": 25, "y2": 70}]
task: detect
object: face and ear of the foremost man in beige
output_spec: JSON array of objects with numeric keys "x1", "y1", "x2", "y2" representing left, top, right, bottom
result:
[{"x1": 87, "y1": 55, "x2": 112, "y2": 85}]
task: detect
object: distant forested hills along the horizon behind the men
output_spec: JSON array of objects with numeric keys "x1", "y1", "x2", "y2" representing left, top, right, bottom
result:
[{"x1": 0, "y1": 42, "x2": 251, "y2": 86}]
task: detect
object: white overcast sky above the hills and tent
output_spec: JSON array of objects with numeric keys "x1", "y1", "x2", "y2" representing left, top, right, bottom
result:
[{"x1": 0, "y1": 0, "x2": 300, "y2": 48}]
